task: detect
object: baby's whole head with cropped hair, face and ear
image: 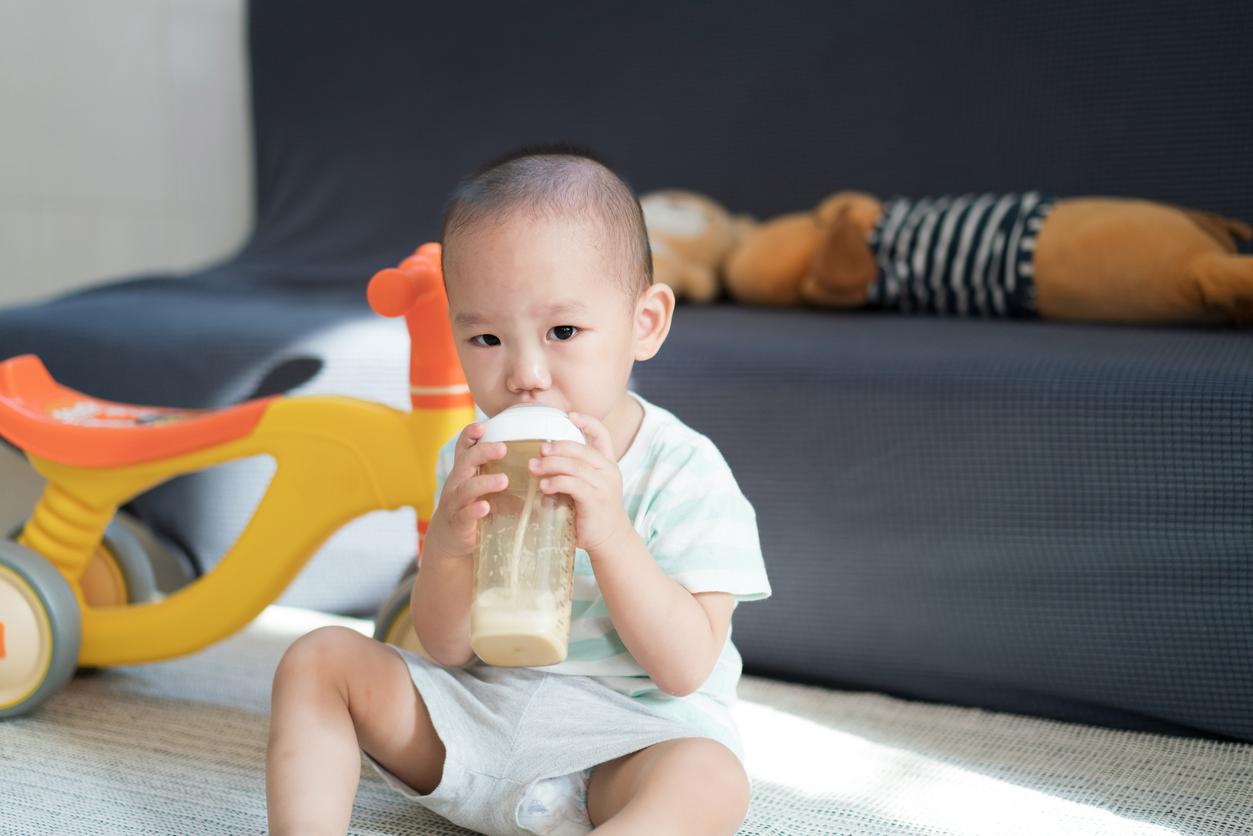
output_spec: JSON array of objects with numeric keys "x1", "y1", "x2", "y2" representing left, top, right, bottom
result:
[{"x1": 441, "y1": 147, "x2": 674, "y2": 420}]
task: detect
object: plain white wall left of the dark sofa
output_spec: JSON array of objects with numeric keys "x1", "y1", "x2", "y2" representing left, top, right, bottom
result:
[{"x1": 0, "y1": 0, "x2": 252, "y2": 306}]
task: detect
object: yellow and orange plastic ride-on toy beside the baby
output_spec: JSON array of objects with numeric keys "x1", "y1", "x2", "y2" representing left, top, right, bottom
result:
[{"x1": 0, "y1": 244, "x2": 474, "y2": 717}]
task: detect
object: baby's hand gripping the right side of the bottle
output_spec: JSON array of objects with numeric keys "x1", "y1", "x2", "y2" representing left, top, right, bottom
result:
[{"x1": 530, "y1": 412, "x2": 634, "y2": 558}]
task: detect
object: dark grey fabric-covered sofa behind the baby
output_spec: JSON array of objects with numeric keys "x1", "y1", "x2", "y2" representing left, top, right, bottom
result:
[{"x1": 0, "y1": 0, "x2": 1253, "y2": 741}]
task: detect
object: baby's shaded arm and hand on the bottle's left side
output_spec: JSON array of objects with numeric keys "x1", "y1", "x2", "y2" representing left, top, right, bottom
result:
[{"x1": 410, "y1": 424, "x2": 509, "y2": 667}]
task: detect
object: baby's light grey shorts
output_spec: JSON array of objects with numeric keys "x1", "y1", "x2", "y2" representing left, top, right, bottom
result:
[{"x1": 366, "y1": 647, "x2": 708, "y2": 836}]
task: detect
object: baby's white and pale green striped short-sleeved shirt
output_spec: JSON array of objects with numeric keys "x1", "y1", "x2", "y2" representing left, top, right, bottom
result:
[{"x1": 436, "y1": 392, "x2": 771, "y2": 752}]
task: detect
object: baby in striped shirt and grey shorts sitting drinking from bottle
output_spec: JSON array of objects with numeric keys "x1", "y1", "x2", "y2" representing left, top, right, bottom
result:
[{"x1": 267, "y1": 147, "x2": 769, "y2": 833}]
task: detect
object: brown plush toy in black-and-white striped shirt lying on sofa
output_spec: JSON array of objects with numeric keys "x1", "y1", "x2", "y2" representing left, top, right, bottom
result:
[{"x1": 725, "y1": 192, "x2": 1253, "y2": 325}]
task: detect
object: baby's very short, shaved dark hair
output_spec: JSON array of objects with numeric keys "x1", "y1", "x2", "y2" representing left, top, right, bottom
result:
[{"x1": 440, "y1": 144, "x2": 653, "y2": 300}]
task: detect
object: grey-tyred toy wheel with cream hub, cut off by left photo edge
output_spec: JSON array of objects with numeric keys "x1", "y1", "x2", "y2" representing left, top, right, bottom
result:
[{"x1": 0, "y1": 541, "x2": 83, "y2": 717}]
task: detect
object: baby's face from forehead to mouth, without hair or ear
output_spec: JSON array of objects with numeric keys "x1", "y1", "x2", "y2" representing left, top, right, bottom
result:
[{"x1": 445, "y1": 216, "x2": 635, "y2": 420}]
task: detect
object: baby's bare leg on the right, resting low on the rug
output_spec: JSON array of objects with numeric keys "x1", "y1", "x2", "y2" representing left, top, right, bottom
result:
[{"x1": 588, "y1": 737, "x2": 749, "y2": 836}]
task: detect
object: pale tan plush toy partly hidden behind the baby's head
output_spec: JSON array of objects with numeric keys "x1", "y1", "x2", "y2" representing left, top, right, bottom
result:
[{"x1": 639, "y1": 189, "x2": 754, "y2": 302}]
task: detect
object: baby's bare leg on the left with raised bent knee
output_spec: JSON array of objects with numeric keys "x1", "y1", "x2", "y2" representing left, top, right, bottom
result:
[{"x1": 266, "y1": 627, "x2": 445, "y2": 835}]
